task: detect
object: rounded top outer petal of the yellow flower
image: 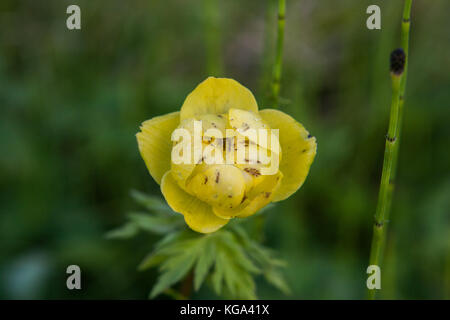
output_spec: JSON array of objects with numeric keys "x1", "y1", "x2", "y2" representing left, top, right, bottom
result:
[{"x1": 180, "y1": 77, "x2": 258, "y2": 120}]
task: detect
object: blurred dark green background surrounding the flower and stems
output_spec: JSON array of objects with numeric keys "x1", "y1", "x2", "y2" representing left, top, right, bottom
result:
[{"x1": 0, "y1": 0, "x2": 450, "y2": 299}]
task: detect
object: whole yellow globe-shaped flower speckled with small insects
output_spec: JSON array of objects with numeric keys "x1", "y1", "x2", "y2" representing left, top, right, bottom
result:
[{"x1": 136, "y1": 77, "x2": 316, "y2": 233}]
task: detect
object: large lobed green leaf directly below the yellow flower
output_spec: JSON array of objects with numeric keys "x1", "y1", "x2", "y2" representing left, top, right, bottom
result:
[{"x1": 144, "y1": 228, "x2": 290, "y2": 299}]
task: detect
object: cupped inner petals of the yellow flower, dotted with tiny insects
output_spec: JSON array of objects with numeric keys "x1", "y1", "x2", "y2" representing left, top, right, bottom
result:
[{"x1": 172, "y1": 109, "x2": 281, "y2": 218}]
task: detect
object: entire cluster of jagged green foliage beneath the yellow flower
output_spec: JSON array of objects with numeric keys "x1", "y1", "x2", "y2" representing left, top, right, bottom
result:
[{"x1": 107, "y1": 191, "x2": 290, "y2": 299}]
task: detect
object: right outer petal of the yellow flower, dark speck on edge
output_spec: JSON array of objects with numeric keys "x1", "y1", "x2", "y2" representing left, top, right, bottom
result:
[{"x1": 260, "y1": 109, "x2": 317, "y2": 201}]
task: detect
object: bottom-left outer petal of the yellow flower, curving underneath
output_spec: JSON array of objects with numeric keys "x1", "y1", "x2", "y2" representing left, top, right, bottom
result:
[{"x1": 161, "y1": 171, "x2": 228, "y2": 233}]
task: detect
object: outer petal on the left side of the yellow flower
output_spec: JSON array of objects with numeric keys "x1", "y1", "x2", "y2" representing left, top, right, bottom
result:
[{"x1": 136, "y1": 112, "x2": 180, "y2": 184}]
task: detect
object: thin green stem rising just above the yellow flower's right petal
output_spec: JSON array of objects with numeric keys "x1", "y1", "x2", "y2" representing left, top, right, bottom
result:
[{"x1": 272, "y1": 0, "x2": 286, "y2": 109}]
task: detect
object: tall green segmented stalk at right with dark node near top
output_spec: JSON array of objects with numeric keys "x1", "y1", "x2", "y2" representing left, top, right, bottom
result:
[{"x1": 368, "y1": 0, "x2": 412, "y2": 299}]
